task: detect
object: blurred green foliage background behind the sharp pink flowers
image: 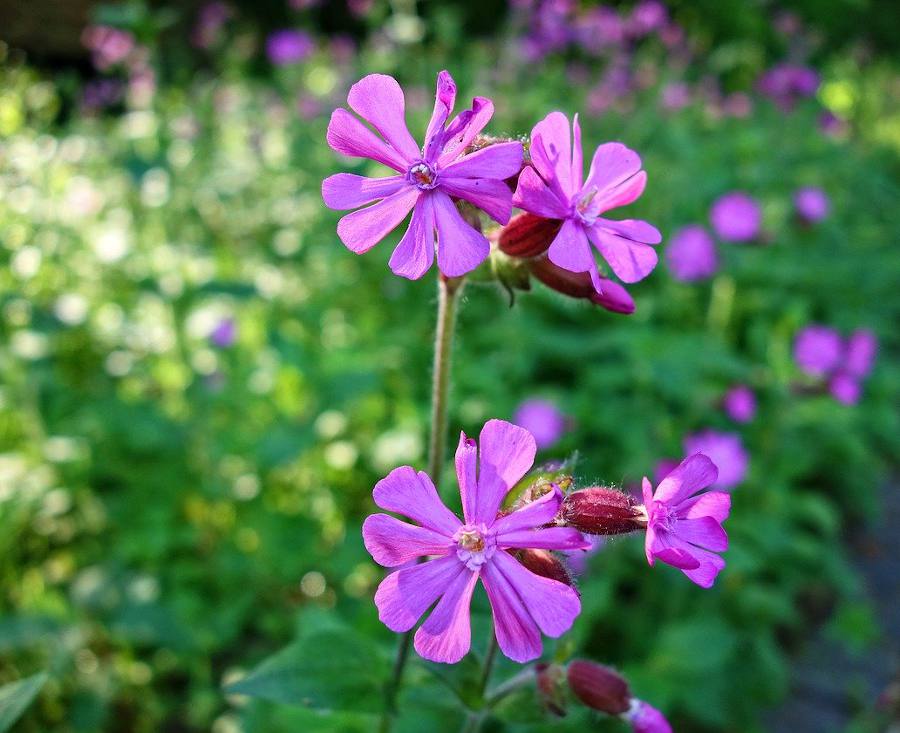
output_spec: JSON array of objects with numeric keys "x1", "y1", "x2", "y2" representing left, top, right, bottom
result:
[{"x1": 0, "y1": 0, "x2": 900, "y2": 733}]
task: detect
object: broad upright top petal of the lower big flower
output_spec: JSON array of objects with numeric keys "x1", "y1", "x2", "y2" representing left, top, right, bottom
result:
[{"x1": 475, "y1": 420, "x2": 537, "y2": 526}]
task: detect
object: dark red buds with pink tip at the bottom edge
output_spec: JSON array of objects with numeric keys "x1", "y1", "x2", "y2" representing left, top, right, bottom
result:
[{"x1": 535, "y1": 659, "x2": 672, "y2": 733}]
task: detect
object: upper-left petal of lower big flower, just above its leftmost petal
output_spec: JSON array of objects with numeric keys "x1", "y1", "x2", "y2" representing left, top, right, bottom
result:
[{"x1": 372, "y1": 466, "x2": 462, "y2": 537}]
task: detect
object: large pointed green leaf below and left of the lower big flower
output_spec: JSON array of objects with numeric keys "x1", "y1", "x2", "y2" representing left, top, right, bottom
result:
[{"x1": 226, "y1": 629, "x2": 388, "y2": 712}]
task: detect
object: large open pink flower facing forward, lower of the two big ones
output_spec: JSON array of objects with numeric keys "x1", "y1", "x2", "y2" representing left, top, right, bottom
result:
[{"x1": 363, "y1": 420, "x2": 590, "y2": 663}]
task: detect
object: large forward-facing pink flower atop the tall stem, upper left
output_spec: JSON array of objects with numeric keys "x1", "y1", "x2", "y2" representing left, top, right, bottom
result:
[{"x1": 322, "y1": 71, "x2": 522, "y2": 280}]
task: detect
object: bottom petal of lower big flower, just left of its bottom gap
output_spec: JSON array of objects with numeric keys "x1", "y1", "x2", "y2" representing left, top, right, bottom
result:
[{"x1": 414, "y1": 571, "x2": 478, "y2": 664}]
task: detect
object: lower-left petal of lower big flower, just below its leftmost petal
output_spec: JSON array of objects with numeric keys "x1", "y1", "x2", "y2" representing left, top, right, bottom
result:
[{"x1": 375, "y1": 555, "x2": 471, "y2": 632}]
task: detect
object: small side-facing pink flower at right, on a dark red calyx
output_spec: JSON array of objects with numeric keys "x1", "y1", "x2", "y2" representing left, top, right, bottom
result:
[{"x1": 643, "y1": 454, "x2": 731, "y2": 588}]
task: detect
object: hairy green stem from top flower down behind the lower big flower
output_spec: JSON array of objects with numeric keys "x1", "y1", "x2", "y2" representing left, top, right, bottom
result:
[{"x1": 378, "y1": 274, "x2": 464, "y2": 733}]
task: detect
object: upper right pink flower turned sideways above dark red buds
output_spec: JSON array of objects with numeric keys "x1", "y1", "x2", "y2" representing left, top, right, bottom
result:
[{"x1": 513, "y1": 112, "x2": 662, "y2": 293}]
